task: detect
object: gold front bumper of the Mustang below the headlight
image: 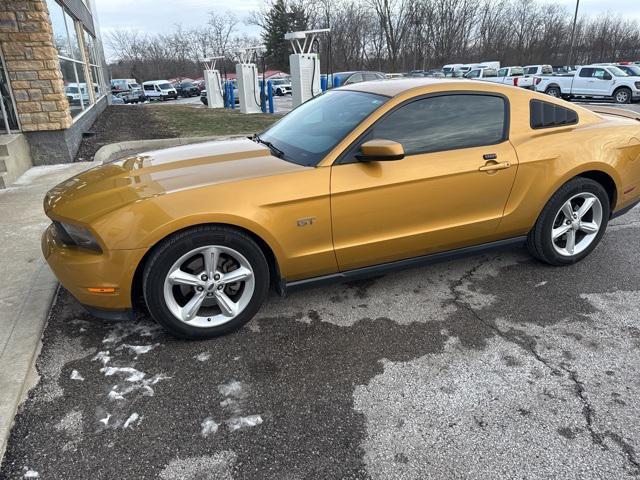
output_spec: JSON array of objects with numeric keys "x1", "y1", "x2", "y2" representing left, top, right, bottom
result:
[{"x1": 42, "y1": 225, "x2": 147, "y2": 318}]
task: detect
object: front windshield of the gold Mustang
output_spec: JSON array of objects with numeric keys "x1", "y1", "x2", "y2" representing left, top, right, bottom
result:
[{"x1": 260, "y1": 90, "x2": 388, "y2": 166}]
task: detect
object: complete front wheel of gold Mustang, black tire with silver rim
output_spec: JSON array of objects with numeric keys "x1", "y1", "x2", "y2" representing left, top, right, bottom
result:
[{"x1": 142, "y1": 226, "x2": 270, "y2": 340}]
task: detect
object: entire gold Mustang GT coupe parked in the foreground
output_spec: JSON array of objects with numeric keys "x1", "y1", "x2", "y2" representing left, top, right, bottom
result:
[{"x1": 42, "y1": 79, "x2": 640, "y2": 338}]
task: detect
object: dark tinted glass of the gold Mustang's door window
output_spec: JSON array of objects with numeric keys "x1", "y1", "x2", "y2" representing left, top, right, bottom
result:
[{"x1": 367, "y1": 94, "x2": 507, "y2": 155}]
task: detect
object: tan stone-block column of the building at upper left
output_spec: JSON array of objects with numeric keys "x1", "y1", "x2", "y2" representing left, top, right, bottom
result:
[{"x1": 0, "y1": 0, "x2": 72, "y2": 132}]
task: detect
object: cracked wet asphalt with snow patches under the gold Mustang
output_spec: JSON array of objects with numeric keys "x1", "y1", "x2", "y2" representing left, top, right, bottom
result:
[{"x1": 0, "y1": 204, "x2": 640, "y2": 480}]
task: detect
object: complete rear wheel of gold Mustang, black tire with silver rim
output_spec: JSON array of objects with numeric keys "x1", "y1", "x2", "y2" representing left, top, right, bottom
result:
[{"x1": 527, "y1": 177, "x2": 611, "y2": 266}]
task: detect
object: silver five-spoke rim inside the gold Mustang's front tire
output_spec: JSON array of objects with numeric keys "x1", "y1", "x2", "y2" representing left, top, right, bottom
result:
[{"x1": 164, "y1": 245, "x2": 255, "y2": 327}]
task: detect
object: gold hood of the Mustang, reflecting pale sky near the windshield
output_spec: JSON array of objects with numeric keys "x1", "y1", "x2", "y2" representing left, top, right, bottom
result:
[{"x1": 44, "y1": 139, "x2": 309, "y2": 221}]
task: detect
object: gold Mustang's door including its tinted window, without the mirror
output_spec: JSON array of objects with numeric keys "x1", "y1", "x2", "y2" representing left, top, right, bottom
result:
[{"x1": 331, "y1": 94, "x2": 518, "y2": 271}]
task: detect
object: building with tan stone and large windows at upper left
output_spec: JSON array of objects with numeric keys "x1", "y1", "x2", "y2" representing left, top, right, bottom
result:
[{"x1": 0, "y1": 0, "x2": 109, "y2": 188}]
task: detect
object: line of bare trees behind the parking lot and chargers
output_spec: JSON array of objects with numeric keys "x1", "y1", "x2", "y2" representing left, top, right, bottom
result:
[{"x1": 106, "y1": 0, "x2": 640, "y2": 79}]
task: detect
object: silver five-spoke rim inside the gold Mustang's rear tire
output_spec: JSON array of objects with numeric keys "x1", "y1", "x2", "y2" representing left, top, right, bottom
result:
[{"x1": 551, "y1": 192, "x2": 602, "y2": 257}]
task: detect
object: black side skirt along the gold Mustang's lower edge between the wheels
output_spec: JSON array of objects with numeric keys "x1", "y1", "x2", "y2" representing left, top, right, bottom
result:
[{"x1": 278, "y1": 236, "x2": 527, "y2": 297}]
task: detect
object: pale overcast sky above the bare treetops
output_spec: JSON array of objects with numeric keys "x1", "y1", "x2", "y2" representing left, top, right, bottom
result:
[{"x1": 95, "y1": 0, "x2": 640, "y2": 52}]
